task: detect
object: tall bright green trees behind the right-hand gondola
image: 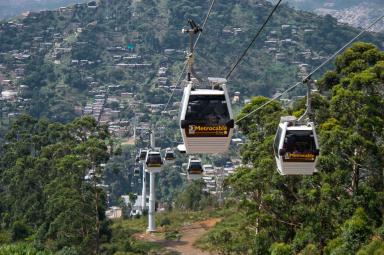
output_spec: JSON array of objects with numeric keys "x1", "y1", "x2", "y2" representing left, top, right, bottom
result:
[{"x1": 200, "y1": 43, "x2": 384, "y2": 255}]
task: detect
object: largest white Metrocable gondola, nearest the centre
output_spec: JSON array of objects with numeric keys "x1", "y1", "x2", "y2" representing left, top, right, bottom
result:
[{"x1": 180, "y1": 78, "x2": 234, "y2": 154}]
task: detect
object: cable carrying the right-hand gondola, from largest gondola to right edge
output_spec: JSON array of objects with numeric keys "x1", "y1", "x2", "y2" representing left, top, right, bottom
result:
[{"x1": 235, "y1": 12, "x2": 384, "y2": 124}]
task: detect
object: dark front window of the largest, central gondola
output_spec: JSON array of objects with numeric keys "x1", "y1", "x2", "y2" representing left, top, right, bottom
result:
[{"x1": 185, "y1": 95, "x2": 230, "y2": 124}]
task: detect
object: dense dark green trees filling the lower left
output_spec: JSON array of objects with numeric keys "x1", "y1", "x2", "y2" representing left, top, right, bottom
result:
[{"x1": 0, "y1": 116, "x2": 112, "y2": 254}]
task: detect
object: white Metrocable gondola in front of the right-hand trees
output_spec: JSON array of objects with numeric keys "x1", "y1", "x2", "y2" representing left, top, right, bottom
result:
[{"x1": 274, "y1": 116, "x2": 320, "y2": 175}]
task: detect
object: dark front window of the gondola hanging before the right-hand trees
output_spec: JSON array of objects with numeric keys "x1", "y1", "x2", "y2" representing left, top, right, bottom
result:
[{"x1": 284, "y1": 131, "x2": 316, "y2": 154}]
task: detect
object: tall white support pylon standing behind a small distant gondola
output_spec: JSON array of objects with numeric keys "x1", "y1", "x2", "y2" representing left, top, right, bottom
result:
[{"x1": 147, "y1": 126, "x2": 156, "y2": 232}]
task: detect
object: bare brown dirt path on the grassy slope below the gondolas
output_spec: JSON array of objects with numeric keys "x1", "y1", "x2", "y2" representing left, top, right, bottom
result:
[{"x1": 136, "y1": 218, "x2": 220, "y2": 255}]
